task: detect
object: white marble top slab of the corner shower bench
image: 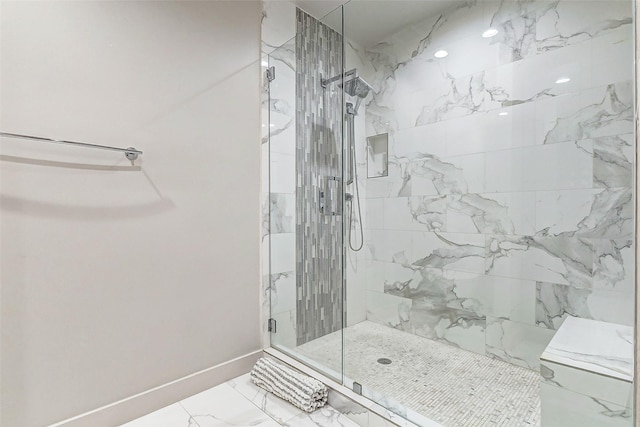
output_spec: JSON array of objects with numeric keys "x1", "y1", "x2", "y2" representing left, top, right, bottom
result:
[{"x1": 540, "y1": 317, "x2": 633, "y2": 382}]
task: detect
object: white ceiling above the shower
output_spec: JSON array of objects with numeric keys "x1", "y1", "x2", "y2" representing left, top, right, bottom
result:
[{"x1": 294, "y1": 0, "x2": 464, "y2": 47}]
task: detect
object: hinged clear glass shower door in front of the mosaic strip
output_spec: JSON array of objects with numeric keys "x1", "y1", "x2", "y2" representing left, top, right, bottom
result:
[{"x1": 269, "y1": 4, "x2": 344, "y2": 381}]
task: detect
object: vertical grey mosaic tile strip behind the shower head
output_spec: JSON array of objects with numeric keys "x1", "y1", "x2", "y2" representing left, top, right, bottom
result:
[{"x1": 296, "y1": 9, "x2": 343, "y2": 345}]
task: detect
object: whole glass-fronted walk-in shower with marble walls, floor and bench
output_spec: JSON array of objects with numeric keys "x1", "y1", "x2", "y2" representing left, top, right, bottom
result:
[{"x1": 263, "y1": 0, "x2": 636, "y2": 427}]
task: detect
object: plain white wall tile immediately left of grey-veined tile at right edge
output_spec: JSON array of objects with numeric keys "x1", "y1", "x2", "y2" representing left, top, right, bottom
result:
[{"x1": 485, "y1": 141, "x2": 593, "y2": 192}]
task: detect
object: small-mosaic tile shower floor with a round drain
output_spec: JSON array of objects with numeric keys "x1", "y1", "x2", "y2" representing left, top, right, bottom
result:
[{"x1": 295, "y1": 321, "x2": 540, "y2": 427}]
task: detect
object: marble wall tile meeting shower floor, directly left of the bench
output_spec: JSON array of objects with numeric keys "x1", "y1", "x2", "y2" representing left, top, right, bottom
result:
[{"x1": 486, "y1": 317, "x2": 555, "y2": 370}]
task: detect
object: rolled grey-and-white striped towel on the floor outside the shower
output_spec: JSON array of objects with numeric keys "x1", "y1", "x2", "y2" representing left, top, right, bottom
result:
[{"x1": 251, "y1": 357, "x2": 329, "y2": 412}]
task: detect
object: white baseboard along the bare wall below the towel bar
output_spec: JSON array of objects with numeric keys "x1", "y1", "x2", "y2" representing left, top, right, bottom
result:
[{"x1": 49, "y1": 350, "x2": 263, "y2": 427}]
